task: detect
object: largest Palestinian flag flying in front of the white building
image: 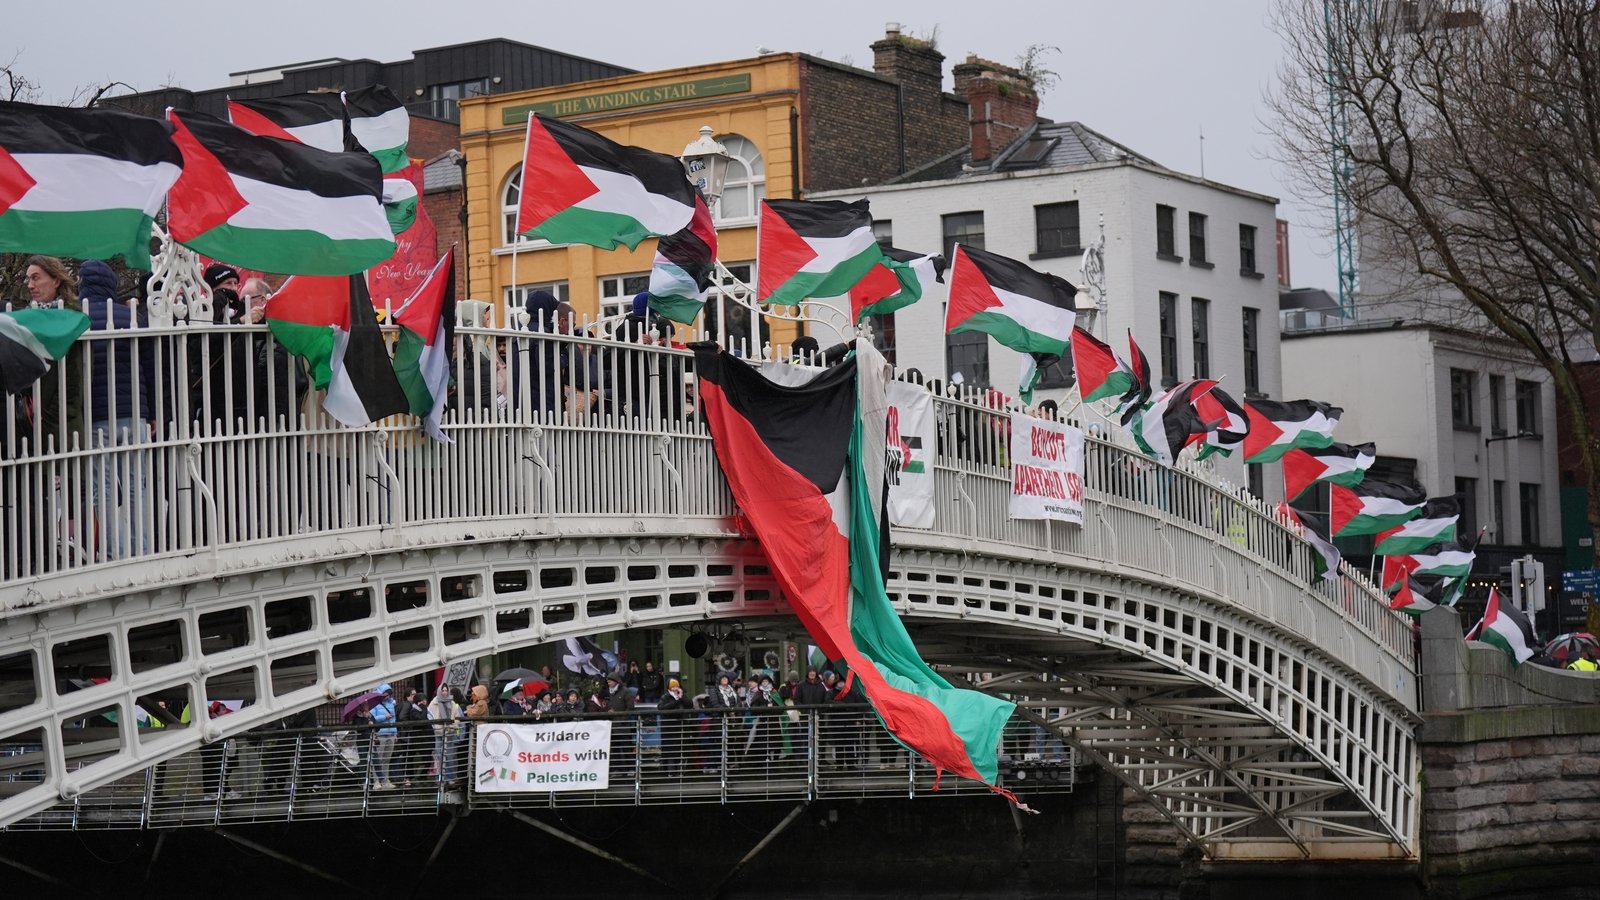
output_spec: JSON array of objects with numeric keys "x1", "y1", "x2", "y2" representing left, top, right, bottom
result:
[{"x1": 944, "y1": 243, "x2": 1078, "y2": 356}]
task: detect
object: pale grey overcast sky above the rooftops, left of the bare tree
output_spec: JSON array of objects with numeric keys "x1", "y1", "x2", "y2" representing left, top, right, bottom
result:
[{"x1": 0, "y1": 0, "x2": 1334, "y2": 288}]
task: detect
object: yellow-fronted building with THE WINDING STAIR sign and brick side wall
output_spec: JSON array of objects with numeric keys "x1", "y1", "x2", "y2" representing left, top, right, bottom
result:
[{"x1": 461, "y1": 30, "x2": 970, "y2": 336}]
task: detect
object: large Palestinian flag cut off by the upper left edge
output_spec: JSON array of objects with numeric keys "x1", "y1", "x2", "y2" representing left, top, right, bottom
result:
[{"x1": 0, "y1": 102, "x2": 182, "y2": 269}]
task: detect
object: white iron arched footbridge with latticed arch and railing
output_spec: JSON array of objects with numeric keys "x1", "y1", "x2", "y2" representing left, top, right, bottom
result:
[{"x1": 0, "y1": 317, "x2": 1421, "y2": 858}]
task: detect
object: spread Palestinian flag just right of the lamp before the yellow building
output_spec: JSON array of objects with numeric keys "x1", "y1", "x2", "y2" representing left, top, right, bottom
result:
[{"x1": 755, "y1": 200, "x2": 885, "y2": 306}]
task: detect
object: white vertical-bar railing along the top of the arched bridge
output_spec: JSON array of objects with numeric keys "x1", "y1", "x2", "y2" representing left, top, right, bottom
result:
[{"x1": 0, "y1": 313, "x2": 1414, "y2": 660}]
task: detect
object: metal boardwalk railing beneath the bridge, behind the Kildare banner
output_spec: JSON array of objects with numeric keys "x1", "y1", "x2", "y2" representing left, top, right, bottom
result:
[{"x1": 0, "y1": 706, "x2": 1078, "y2": 830}]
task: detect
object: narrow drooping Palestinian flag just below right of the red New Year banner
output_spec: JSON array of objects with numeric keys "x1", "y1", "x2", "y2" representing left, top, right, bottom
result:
[{"x1": 394, "y1": 248, "x2": 456, "y2": 444}]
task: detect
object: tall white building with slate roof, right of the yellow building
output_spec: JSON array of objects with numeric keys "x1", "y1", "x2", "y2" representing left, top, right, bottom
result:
[{"x1": 808, "y1": 72, "x2": 1285, "y2": 495}]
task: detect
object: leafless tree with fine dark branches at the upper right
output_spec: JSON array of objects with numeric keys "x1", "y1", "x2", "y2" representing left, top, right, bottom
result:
[{"x1": 1272, "y1": 0, "x2": 1600, "y2": 560}]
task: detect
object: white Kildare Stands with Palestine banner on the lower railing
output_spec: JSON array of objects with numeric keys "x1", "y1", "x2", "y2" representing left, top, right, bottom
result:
[{"x1": 472, "y1": 721, "x2": 611, "y2": 794}]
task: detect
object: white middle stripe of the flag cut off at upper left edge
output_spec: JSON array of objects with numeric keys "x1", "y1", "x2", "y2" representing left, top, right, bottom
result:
[{"x1": 11, "y1": 154, "x2": 179, "y2": 216}]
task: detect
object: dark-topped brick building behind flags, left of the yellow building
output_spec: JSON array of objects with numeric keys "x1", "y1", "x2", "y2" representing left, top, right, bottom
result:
[{"x1": 107, "y1": 38, "x2": 632, "y2": 296}]
